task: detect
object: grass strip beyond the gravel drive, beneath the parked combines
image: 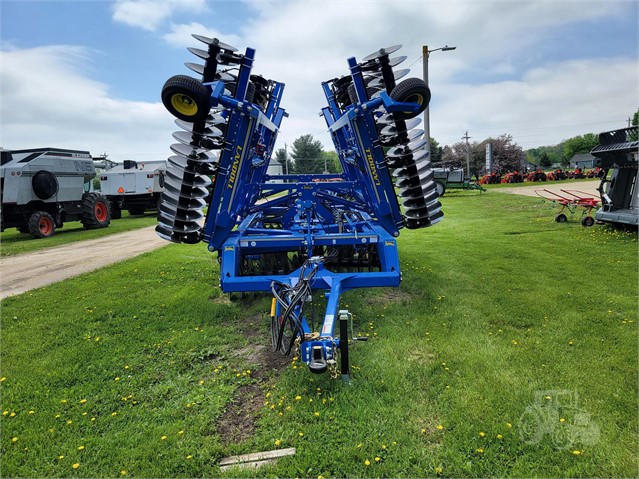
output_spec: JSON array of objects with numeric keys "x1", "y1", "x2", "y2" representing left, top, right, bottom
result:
[{"x1": 0, "y1": 211, "x2": 157, "y2": 256}]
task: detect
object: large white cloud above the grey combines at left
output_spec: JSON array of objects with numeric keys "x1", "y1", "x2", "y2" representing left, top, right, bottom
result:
[{"x1": 0, "y1": 45, "x2": 175, "y2": 160}]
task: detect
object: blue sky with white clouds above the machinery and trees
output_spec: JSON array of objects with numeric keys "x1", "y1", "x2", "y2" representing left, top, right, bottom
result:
[{"x1": 0, "y1": 0, "x2": 639, "y2": 160}]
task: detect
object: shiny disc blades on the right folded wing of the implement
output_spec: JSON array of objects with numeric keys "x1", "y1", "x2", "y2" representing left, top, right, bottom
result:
[{"x1": 334, "y1": 45, "x2": 444, "y2": 229}]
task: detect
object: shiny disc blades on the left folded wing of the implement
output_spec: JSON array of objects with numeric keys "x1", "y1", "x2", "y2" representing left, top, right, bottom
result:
[{"x1": 155, "y1": 35, "x2": 242, "y2": 243}]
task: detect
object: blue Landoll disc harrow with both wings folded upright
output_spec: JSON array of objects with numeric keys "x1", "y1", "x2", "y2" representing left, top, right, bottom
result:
[{"x1": 156, "y1": 35, "x2": 443, "y2": 381}]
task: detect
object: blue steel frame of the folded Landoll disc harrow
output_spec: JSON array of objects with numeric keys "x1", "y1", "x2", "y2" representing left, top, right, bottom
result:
[{"x1": 198, "y1": 49, "x2": 419, "y2": 378}]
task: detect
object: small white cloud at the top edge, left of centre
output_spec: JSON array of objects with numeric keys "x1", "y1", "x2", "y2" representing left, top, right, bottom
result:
[{"x1": 113, "y1": 0, "x2": 206, "y2": 31}]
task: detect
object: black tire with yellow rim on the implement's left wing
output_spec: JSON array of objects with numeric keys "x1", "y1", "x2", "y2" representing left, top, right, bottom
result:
[{"x1": 162, "y1": 75, "x2": 211, "y2": 123}]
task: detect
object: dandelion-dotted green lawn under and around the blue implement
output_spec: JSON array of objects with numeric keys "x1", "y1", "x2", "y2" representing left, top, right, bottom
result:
[{"x1": 0, "y1": 192, "x2": 638, "y2": 477}]
